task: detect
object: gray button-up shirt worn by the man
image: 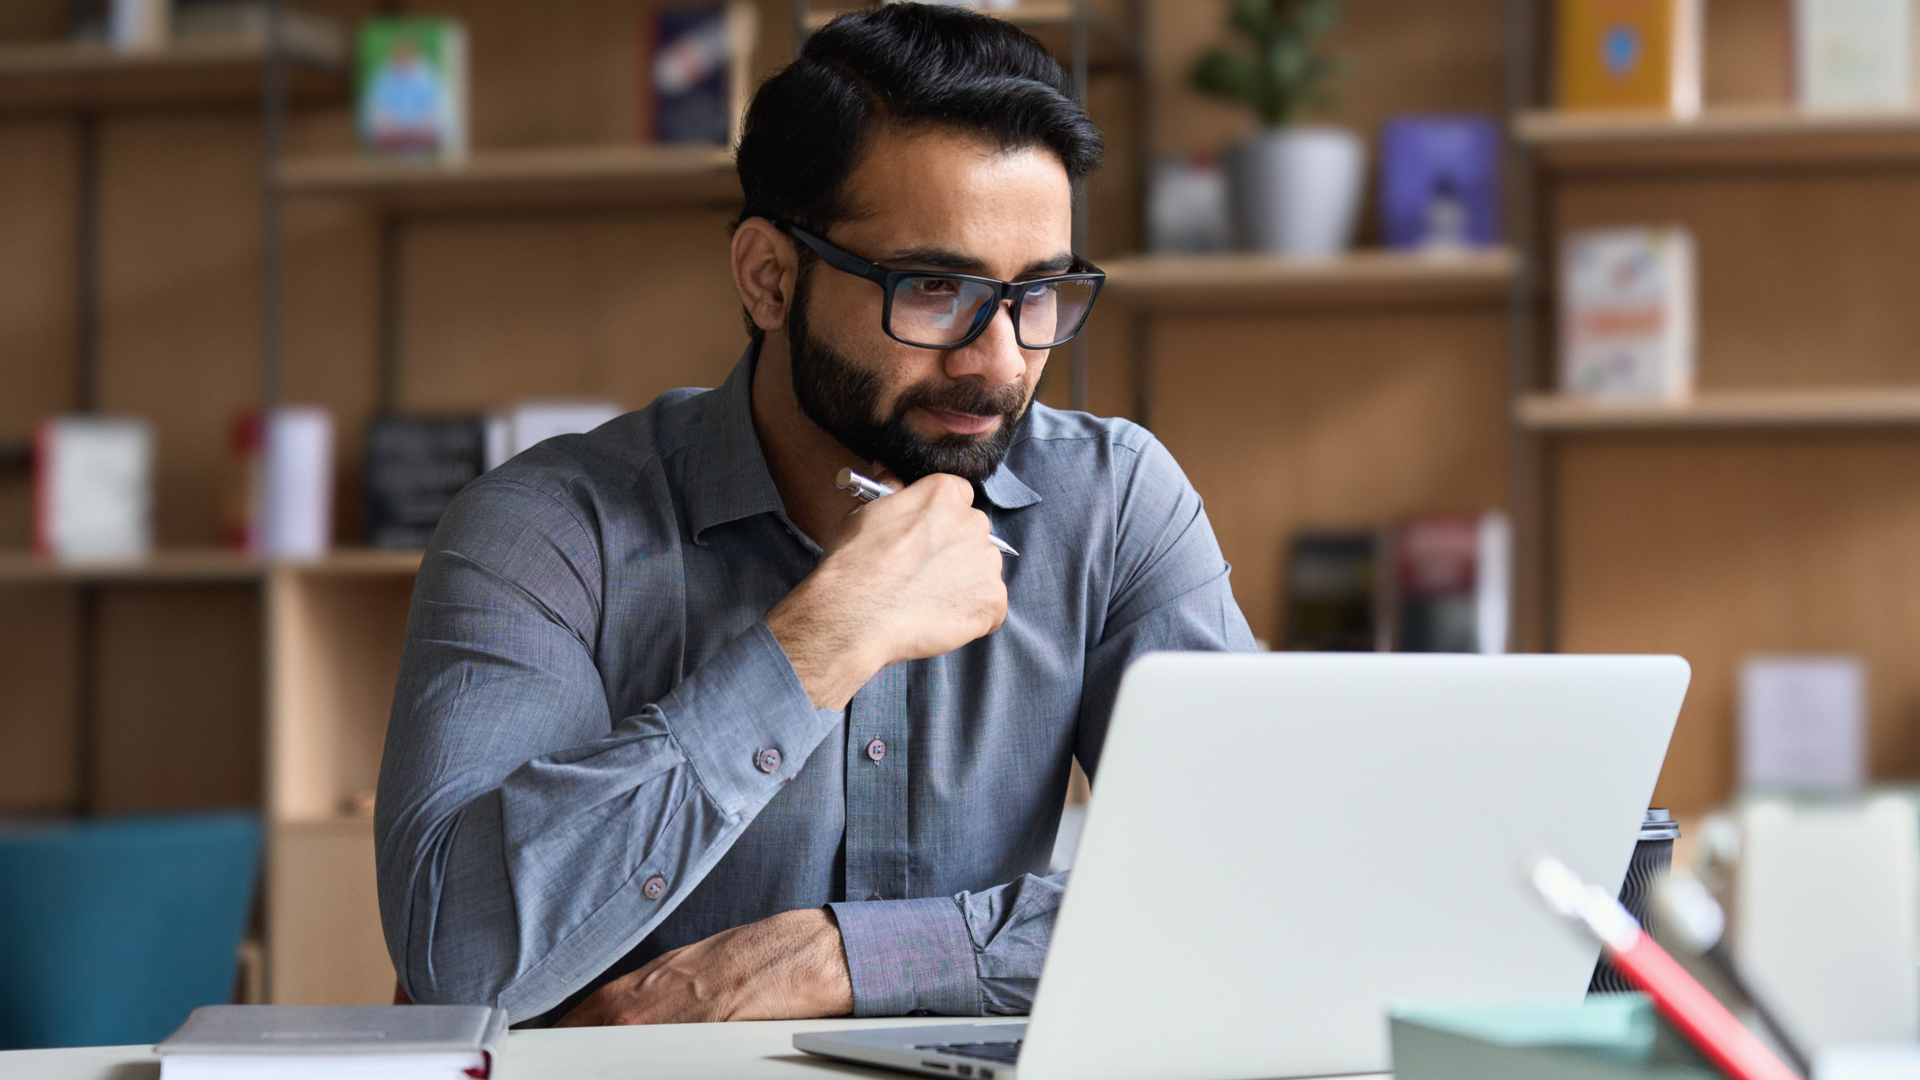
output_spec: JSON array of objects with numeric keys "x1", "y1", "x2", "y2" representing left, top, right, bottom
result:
[{"x1": 374, "y1": 350, "x2": 1254, "y2": 1020}]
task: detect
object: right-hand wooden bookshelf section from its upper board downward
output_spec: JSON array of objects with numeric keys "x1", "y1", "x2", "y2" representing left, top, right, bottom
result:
[{"x1": 1511, "y1": 90, "x2": 1920, "y2": 813}]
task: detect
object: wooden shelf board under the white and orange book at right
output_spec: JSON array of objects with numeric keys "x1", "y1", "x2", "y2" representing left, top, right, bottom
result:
[{"x1": 1515, "y1": 386, "x2": 1920, "y2": 434}]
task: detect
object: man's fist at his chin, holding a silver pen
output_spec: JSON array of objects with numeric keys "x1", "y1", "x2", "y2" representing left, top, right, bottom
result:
[{"x1": 766, "y1": 473, "x2": 1006, "y2": 709}]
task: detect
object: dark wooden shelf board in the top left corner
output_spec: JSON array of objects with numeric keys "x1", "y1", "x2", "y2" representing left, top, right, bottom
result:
[{"x1": 0, "y1": 40, "x2": 348, "y2": 113}]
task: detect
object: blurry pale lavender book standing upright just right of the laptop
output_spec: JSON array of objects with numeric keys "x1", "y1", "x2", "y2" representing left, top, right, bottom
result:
[{"x1": 1740, "y1": 655, "x2": 1866, "y2": 790}]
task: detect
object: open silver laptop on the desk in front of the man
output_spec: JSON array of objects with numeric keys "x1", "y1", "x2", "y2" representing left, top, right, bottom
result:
[{"x1": 793, "y1": 653, "x2": 1690, "y2": 1080}]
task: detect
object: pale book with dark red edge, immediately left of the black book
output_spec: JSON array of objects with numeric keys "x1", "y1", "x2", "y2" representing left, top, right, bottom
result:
[{"x1": 227, "y1": 405, "x2": 334, "y2": 559}]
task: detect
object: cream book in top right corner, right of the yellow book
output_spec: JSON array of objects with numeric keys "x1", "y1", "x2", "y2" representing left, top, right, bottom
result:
[{"x1": 1789, "y1": 0, "x2": 1914, "y2": 110}]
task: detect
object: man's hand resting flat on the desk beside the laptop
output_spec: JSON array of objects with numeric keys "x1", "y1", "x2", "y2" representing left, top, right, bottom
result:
[{"x1": 557, "y1": 909, "x2": 852, "y2": 1028}]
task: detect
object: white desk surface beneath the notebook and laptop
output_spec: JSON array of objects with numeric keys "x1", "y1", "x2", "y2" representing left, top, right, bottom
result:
[{"x1": 0, "y1": 1017, "x2": 966, "y2": 1080}]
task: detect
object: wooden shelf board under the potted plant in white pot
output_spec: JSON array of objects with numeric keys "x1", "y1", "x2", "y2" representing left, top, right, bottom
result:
[{"x1": 1100, "y1": 248, "x2": 1519, "y2": 311}]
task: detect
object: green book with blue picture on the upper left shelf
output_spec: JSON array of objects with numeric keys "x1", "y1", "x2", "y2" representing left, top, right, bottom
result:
[{"x1": 355, "y1": 17, "x2": 467, "y2": 161}]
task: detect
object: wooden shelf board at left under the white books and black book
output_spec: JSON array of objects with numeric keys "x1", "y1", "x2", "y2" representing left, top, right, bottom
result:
[{"x1": 0, "y1": 548, "x2": 420, "y2": 584}]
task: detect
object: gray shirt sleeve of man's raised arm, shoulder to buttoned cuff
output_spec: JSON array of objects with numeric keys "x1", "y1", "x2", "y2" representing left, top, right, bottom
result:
[{"x1": 374, "y1": 472, "x2": 839, "y2": 1020}]
